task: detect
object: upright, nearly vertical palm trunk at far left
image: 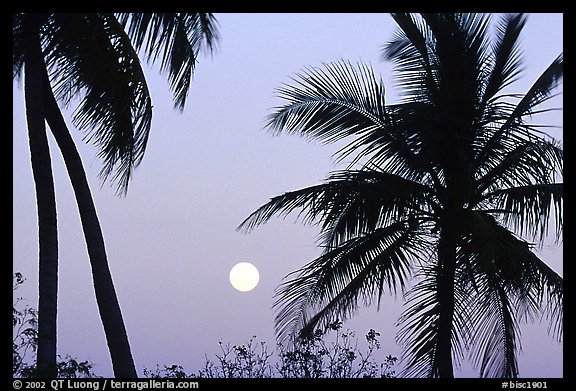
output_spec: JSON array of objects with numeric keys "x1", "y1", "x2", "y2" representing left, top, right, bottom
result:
[{"x1": 24, "y1": 14, "x2": 58, "y2": 378}]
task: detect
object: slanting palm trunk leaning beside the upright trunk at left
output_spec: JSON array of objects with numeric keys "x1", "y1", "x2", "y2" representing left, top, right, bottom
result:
[{"x1": 43, "y1": 73, "x2": 138, "y2": 378}]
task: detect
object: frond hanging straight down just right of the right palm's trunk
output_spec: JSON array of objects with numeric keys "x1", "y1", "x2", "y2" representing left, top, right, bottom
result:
[{"x1": 457, "y1": 211, "x2": 534, "y2": 377}]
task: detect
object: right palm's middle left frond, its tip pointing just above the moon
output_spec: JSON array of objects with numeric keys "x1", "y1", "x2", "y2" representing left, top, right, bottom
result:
[{"x1": 238, "y1": 170, "x2": 431, "y2": 247}]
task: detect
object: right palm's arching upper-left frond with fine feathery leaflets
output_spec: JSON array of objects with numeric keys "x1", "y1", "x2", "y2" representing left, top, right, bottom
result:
[{"x1": 267, "y1": 61, "x2": 444, "y2": 186}]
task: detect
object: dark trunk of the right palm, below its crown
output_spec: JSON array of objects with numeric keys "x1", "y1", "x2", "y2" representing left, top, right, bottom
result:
[{"x1": 435, "y1": 222, "x2": 456, "y2": 378}]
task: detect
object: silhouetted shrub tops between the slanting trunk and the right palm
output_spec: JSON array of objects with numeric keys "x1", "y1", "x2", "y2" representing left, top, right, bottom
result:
[{"x1": 144, "y1": 322, "x2": 397, "y2": 378}]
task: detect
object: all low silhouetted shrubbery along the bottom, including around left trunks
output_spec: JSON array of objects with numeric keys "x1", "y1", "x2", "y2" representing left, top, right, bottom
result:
[{"x1": 12, "y1": 273, "x2": 397, "y2": 379}]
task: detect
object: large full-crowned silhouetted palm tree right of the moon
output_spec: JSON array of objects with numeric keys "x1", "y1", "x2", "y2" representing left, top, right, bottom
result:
[{"x1": 239, "y1": 14, "x2": 563, "y2": 378}]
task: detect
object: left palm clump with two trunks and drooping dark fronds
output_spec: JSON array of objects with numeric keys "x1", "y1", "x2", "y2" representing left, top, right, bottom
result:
[{"x1": 13, "y1": 13, "x2": 218, "y2": 377}]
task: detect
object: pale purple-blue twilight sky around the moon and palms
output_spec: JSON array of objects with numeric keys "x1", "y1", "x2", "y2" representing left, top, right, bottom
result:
[{"x1": 13, "y1": 13, "x2": 563, "y2": 377}]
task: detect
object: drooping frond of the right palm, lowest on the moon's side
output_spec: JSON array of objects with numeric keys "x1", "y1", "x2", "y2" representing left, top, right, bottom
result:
[{"x1": 274, "y1": 222, "x2": 423, "y2": 340}]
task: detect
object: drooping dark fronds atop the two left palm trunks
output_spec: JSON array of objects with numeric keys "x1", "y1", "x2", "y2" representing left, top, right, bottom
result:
[{"x1": 13, "y1": 13, "x2": 218, "y2": 194}]
